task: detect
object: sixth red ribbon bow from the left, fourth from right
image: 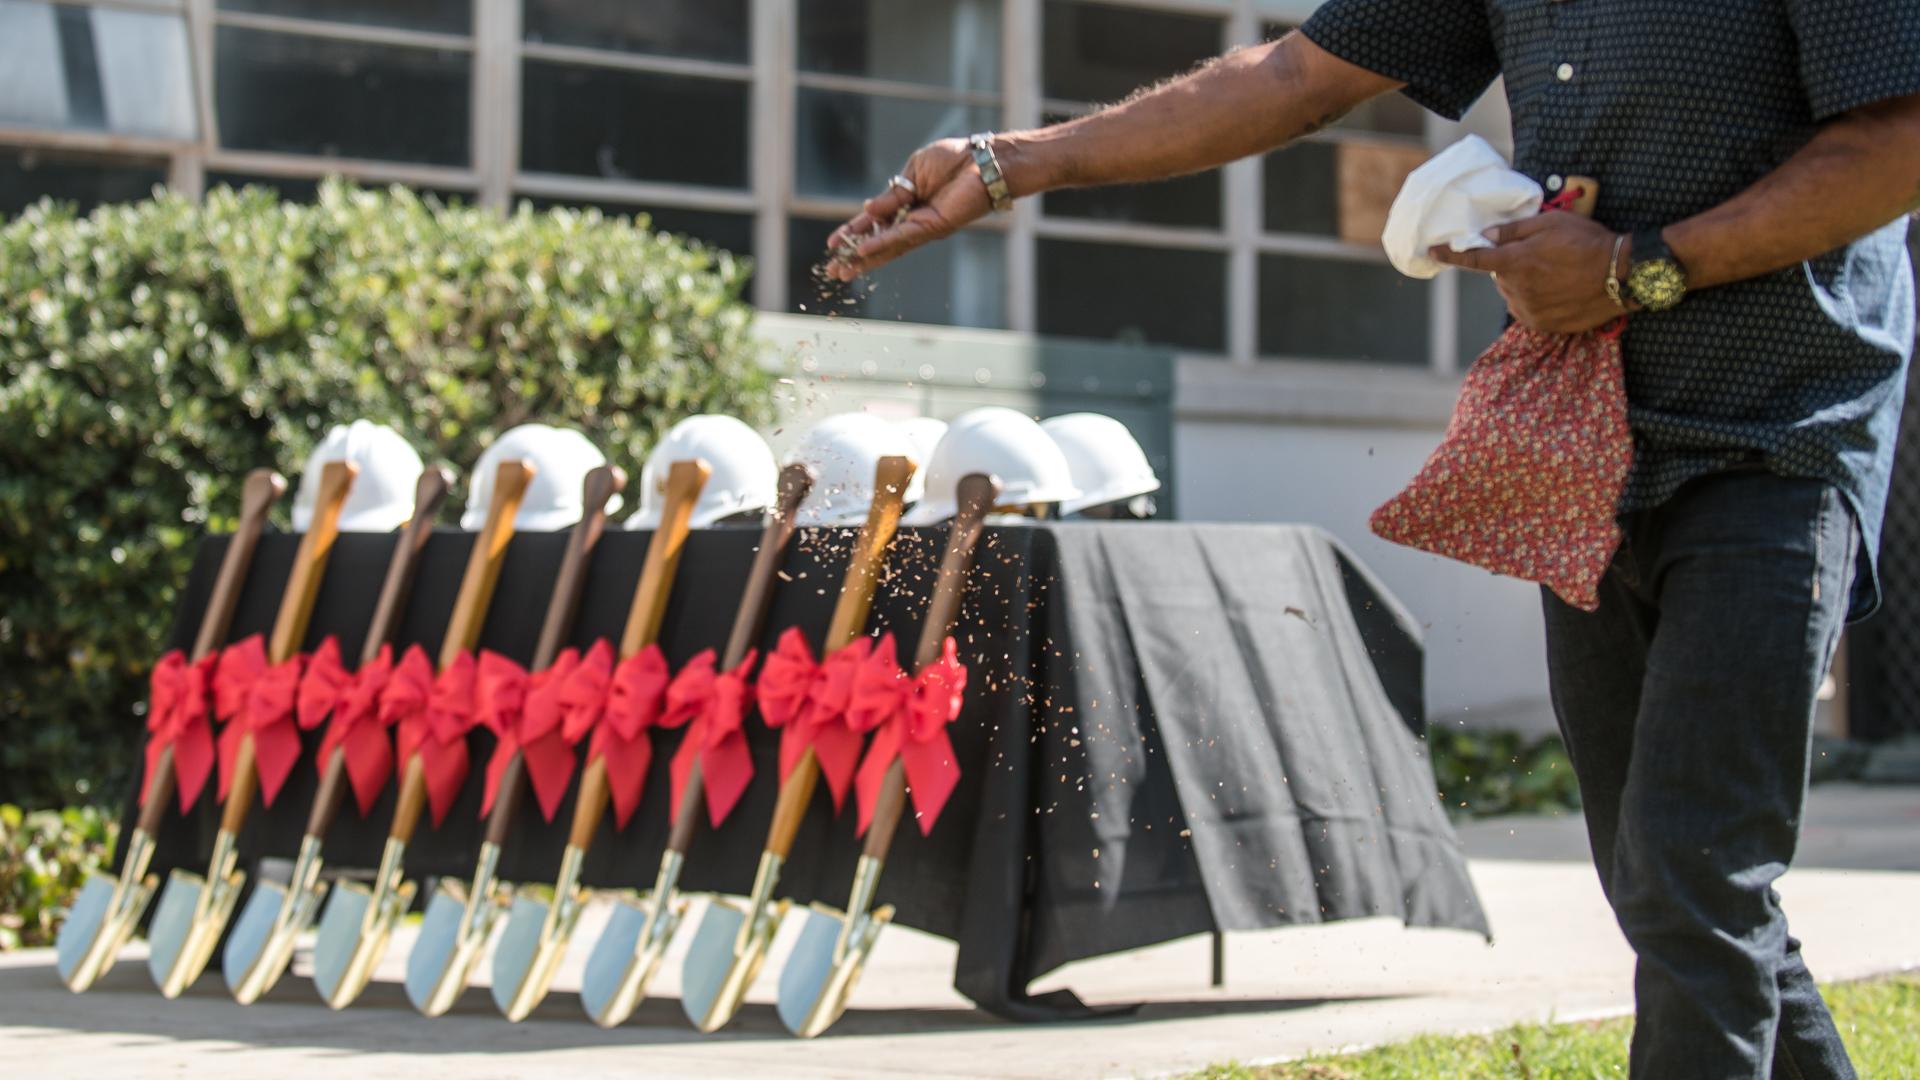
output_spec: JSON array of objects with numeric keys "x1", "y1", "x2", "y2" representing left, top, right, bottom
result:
[{"x1": 561, "y1": 642, "x2": 668, "y2": 828}]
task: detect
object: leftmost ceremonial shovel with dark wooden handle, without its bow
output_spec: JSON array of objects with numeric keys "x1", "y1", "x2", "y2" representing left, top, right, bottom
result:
[{"x1": 54, "y1": 469, "x2": 286, "y2": 994}]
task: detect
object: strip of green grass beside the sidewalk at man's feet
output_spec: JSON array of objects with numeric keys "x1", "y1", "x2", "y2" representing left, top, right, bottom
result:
[{"x1": 1192, "y1": 972, "x2": 1920, "y2": 1080}]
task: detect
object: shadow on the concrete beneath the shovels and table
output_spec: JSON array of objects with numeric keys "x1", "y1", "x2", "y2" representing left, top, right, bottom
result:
[{"x1": 0, "y1": 953, "x2": 1413, "y2": 1055}]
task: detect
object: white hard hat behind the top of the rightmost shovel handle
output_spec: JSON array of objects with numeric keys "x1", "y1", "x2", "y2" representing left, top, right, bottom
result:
[{"x1": 902, "y1": 405, "x2": 1079, "y2": 525}]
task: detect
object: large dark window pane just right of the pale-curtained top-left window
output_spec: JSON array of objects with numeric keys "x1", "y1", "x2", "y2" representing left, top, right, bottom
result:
[{"x1": 213, "y1": 27, "x2": 472, "y2": 165}]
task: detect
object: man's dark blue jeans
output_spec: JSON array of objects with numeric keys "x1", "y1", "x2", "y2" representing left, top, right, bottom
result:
[{"x1": 1546, "y1": 469, "x2": 1859, "y2": 1080}]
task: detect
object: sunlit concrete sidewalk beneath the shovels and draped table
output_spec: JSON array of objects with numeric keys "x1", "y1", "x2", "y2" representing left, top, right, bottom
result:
[{"x1": 0, "y1": 786, "x2": 1920, "y2": 1080}]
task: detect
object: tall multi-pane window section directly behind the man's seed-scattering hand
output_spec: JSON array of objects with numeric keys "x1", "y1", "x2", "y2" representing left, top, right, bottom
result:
[{"x1": 785, "y1": 0, "x2": 1006, "y2": 327}]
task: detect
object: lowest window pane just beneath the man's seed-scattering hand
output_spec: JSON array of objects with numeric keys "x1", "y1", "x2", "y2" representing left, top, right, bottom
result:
[{"x1": 787, "y1": 217, "x2": 1006, "y2": 329}]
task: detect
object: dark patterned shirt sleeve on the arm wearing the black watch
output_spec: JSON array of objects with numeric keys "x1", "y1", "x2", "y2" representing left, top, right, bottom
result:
[{"x1": 1788, "y1": 0, "x2": 1920, "y2": 121}]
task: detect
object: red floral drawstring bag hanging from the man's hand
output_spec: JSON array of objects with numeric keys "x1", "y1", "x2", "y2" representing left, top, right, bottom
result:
[{"x1": 1369, "y1": 188, "x2": 1634, "y2": 611}]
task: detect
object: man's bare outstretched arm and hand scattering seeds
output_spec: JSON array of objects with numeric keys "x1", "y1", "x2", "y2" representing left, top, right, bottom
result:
[{"x1": 828, "y1": 33, "x2": 1400, "y2": 281}]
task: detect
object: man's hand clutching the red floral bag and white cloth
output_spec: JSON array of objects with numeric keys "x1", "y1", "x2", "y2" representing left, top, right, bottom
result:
[{"x1": 1428, "y1": 213, "x2": 1628, "y2": 334}]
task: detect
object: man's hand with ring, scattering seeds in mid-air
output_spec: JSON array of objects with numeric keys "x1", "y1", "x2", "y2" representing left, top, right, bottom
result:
[{"x1": 826, "y1": 138, "x2": 993, "y2": 281}]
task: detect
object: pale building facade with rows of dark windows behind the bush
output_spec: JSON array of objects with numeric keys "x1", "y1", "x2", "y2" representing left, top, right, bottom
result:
[{"x1": 0, "y1": 0, "x2": 1904, "y2": 728}]
